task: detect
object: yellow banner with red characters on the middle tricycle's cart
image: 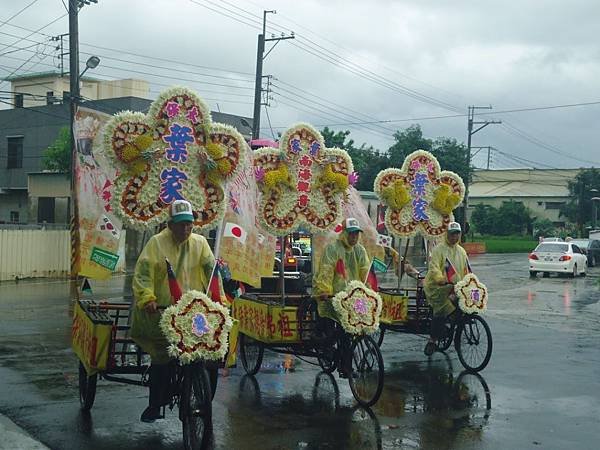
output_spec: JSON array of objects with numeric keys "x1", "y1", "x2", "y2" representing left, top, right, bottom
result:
[{"x1": 233, "y1": 298, "x2": 300, "y2": 343}]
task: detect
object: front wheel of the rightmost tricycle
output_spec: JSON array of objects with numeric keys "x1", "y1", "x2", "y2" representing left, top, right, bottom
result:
[{"x1": 454, "y1": 314, "x2": 492, "y2": 372}]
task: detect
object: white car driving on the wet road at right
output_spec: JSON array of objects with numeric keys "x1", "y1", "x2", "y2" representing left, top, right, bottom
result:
[{"x1": 529, "y1": 241, "x2": 587, "y2": 277}]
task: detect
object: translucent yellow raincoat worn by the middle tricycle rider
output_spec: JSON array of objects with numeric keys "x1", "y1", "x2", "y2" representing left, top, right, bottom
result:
[{"x1": 313, "y1": 230, "x2": 371, "y2": 319}]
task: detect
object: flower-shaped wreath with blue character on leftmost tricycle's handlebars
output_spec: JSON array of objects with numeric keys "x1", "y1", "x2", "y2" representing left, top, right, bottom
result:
[{"x1": 160, "y1": 291, "x2": 233, "y2": 364}]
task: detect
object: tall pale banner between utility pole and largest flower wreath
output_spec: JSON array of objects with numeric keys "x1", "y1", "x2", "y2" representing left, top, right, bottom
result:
[{"x1": 73, "y1": 108, "x2": 122, "y2": 279}]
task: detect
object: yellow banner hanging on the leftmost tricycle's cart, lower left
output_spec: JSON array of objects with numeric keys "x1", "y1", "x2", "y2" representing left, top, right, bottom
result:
[{"x1": 71, "y1": 302, "x2": 112, "y2": 375}]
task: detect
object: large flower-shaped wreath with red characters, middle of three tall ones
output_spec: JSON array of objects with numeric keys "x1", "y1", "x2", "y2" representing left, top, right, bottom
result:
[{"x1": 254, "y1": 124, "x2": 356, "y2": 236}]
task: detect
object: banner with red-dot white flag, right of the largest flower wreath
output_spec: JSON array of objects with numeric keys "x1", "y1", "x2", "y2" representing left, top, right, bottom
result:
[{"x1": 218, "y1": 146, "x2": 276, "y2": 288}]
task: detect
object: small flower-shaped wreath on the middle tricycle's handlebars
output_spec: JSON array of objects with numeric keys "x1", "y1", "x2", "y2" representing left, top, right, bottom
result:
[{"x1": 331, "y1": 280, "x2": 382, "y2": 334}]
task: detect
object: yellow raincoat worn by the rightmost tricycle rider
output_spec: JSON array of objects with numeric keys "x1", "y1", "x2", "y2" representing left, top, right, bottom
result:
[{"x1": 424, "y1": 237, "x2": 469, "y2": 316}]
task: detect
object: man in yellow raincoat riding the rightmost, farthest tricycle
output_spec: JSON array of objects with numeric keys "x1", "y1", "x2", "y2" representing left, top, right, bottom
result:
[{"x1": 424, "y1": 222, "x2": 470, "y2": 356}]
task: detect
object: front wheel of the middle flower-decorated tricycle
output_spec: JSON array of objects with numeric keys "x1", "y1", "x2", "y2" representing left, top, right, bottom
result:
[{"x1": 348, "y1": 336, "x2": 383, "y2": 407}]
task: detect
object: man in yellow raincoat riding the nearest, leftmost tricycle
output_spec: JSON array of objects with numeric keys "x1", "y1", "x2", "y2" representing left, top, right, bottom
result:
[{"x1": 131, "y1": 200, "x2": 225, "y2": 422}]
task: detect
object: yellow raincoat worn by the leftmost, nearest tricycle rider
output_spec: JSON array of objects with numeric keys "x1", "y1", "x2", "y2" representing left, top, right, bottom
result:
[{"x1": 131, "y1": 228, "x2": 226, "y2": 364}]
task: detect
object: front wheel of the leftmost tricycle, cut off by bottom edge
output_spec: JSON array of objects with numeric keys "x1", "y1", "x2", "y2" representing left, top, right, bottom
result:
[{"x1": 179, "y1": 363, "x2": 212, "y2": 450}]
